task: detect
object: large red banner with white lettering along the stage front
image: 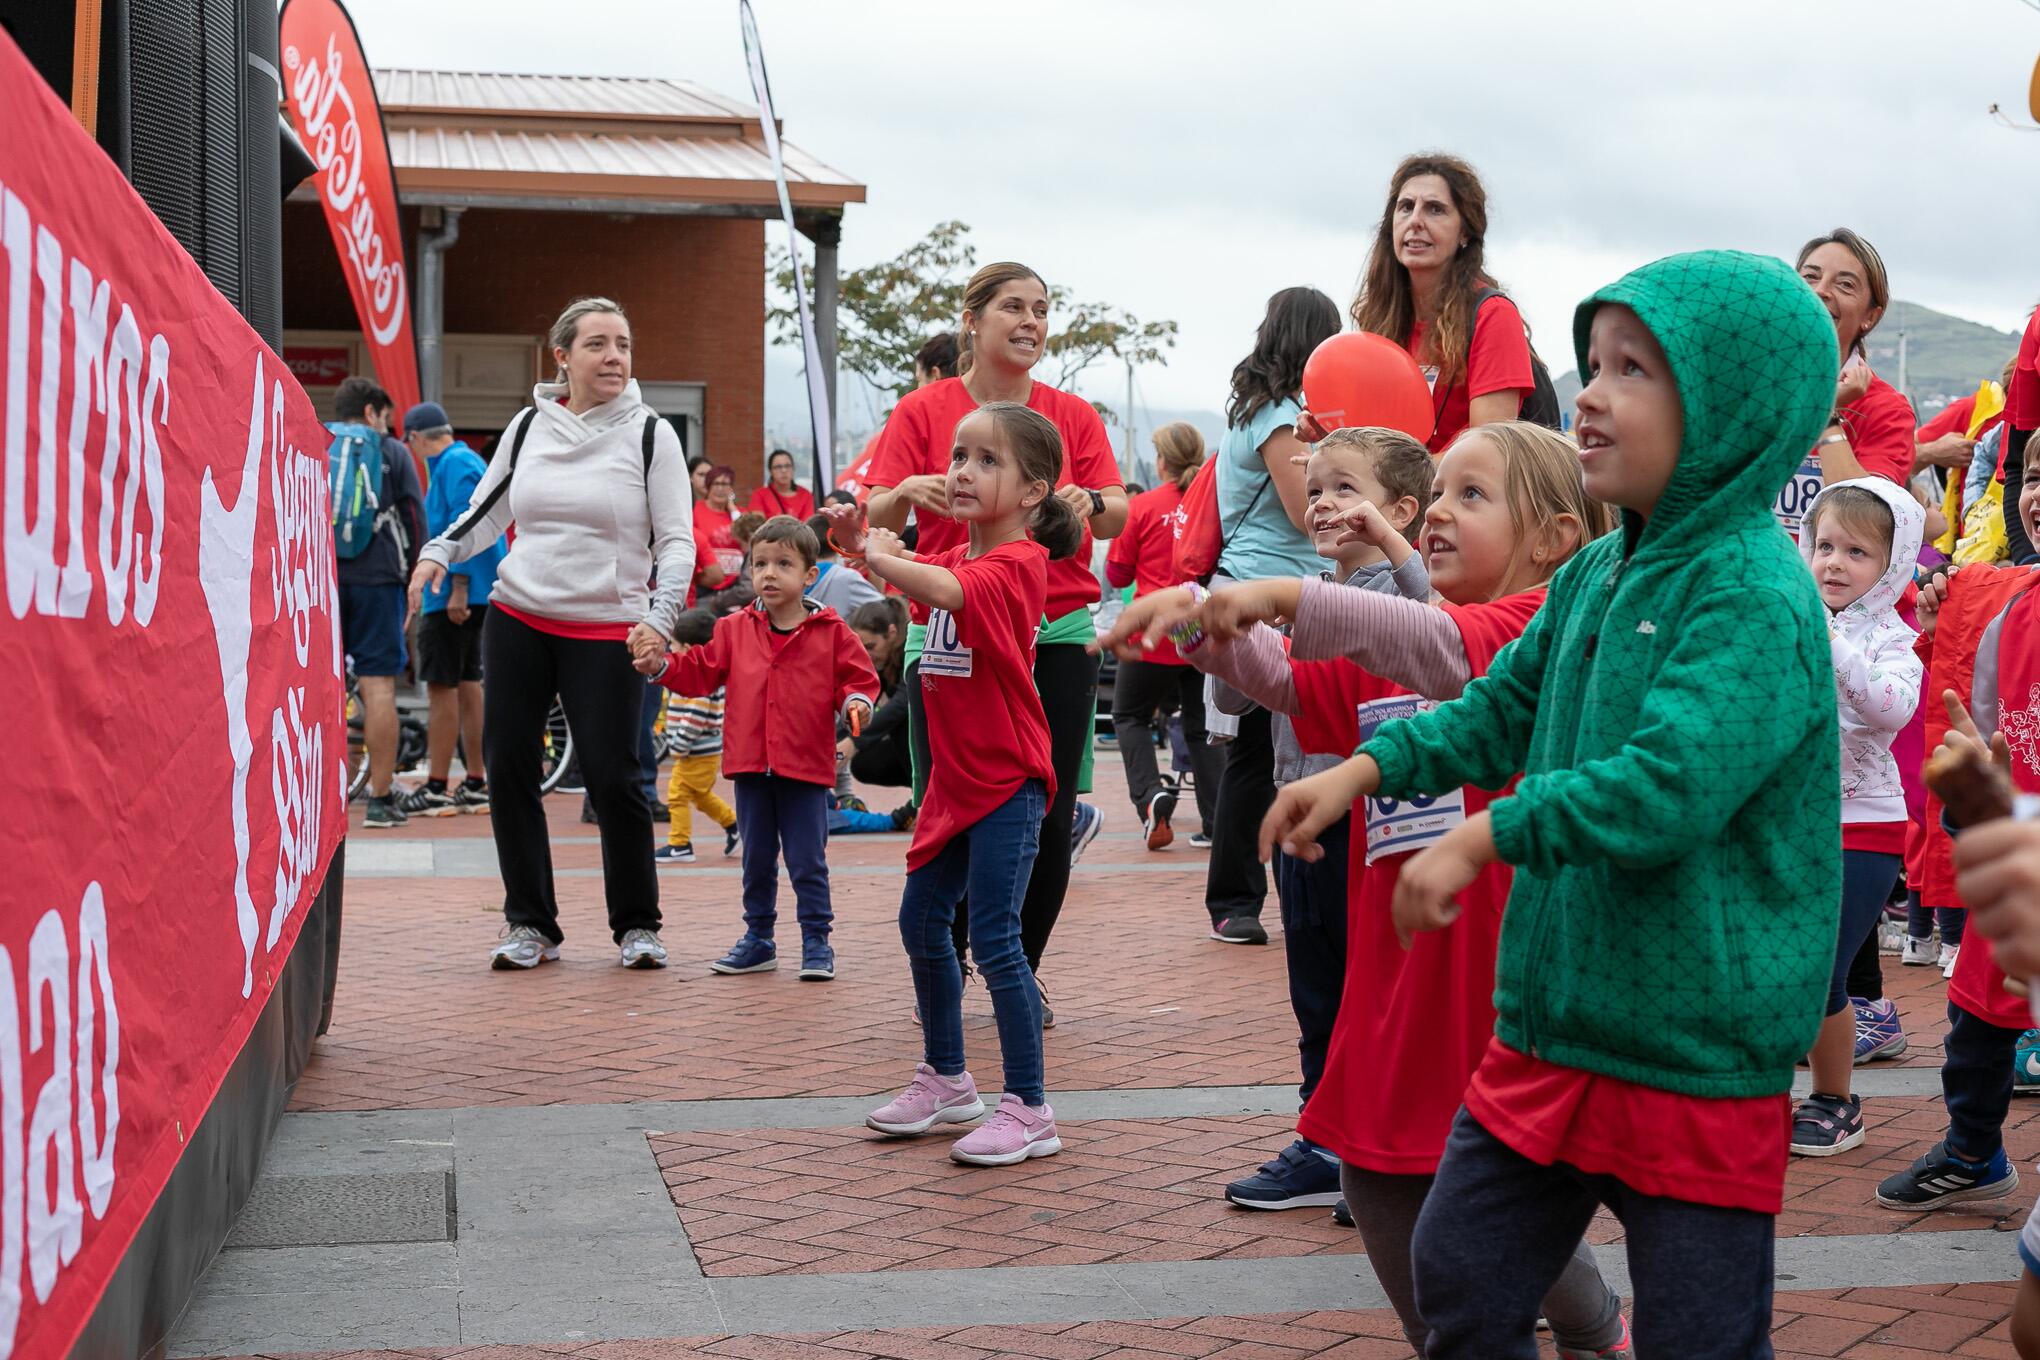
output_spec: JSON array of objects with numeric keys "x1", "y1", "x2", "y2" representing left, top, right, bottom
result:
[{"x1": 0, "y1": 35, "x2": 347, "y2": 1358}]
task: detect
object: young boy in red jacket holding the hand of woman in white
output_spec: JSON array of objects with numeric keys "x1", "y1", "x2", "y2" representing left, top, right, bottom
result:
[{"x1": 636, "y1": 516, "x2": 879, "y2": 983}]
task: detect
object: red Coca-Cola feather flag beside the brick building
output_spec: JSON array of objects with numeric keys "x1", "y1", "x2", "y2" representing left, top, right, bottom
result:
[{"x1": 282, "y1": 0, "x2": 418, "y2": 426}]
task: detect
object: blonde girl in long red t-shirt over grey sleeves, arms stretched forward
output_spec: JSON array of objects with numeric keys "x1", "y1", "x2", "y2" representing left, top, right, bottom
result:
[{"x1": 1108, "y1": 422, "x2": 1626, "y2": 1356}]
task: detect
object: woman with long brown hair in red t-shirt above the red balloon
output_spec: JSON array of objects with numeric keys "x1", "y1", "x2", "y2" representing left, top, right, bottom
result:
[{"x1": 1353, "y1": 155, "x2": 1536, "y2": 453}]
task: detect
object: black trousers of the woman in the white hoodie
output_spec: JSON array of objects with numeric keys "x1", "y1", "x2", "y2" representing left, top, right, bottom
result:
[{"x1": 481, "y1": 610, "x2": 659, "y2": 944}]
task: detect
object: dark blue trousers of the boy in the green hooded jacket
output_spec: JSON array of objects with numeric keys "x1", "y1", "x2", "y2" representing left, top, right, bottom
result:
[{"x1": 1412, "y1": 1109, "x2": 1775, "y2": 1360}]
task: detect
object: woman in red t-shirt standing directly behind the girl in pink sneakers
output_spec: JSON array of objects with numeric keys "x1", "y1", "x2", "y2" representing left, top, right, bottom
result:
[{"x1": 865, "y1": 261, "x2": 1126, "y2": 999}]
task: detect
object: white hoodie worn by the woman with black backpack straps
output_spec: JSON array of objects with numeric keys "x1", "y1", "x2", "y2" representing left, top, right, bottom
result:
[{"x1": 420, "y1": 381, "x2": 694, "y2": 636}]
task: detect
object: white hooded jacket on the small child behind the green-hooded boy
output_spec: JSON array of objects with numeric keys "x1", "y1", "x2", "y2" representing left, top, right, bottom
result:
[{"x1": 1799, "y1": 477, "x2": 1926, "y2": 826}]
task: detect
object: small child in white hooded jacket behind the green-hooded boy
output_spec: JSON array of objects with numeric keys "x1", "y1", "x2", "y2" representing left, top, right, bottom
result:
[{"x1": 1791, "y1": 477, "x2": 1926, "y2": 1156}]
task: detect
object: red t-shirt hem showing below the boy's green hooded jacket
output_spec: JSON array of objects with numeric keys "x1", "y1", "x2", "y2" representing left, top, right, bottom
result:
[{"x1": 1467, "y1": 1035, "x2": 1787, "y2": 1213}]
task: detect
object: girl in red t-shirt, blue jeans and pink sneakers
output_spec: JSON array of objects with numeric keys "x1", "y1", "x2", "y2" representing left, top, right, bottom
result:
[{"x1": 830, "y1": 402, "x2": 1083, "y2": 1166}]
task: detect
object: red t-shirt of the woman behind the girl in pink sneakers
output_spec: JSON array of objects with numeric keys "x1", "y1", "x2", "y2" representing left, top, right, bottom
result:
[{"x1": 865, "y1": 377, "x2": 1120, "y2": 624}]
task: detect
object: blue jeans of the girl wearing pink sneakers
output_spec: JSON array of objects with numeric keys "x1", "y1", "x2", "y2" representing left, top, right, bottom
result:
[{"x1": 900, "y1": 779, "x2": 1049, "y2": 1105}]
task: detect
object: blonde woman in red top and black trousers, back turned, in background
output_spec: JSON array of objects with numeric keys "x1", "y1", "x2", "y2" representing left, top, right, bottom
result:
[{"x1": 1106, "y1": 420, "x2": 1224, "y2": 850}]
